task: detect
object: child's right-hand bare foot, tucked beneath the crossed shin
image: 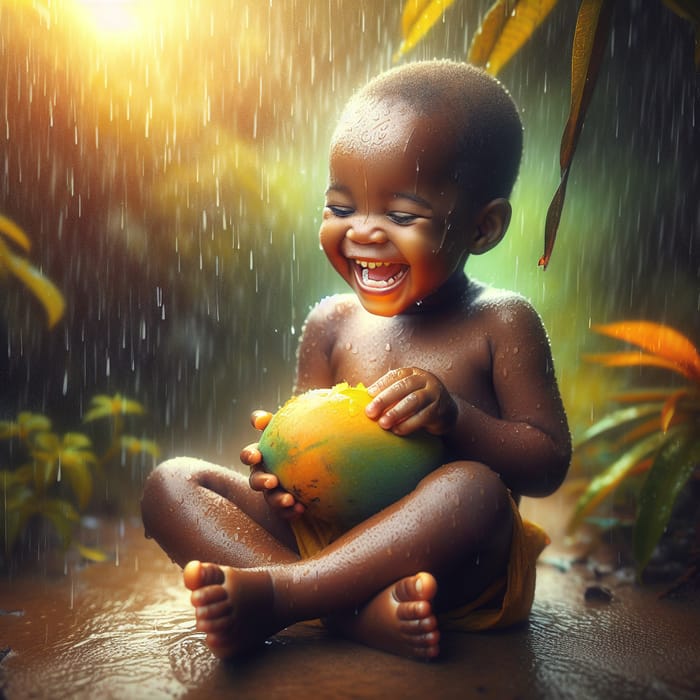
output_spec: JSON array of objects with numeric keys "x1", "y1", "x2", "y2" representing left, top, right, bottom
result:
[{"x1": 330, "y1": 571, "x2": 440, "y2": 659}]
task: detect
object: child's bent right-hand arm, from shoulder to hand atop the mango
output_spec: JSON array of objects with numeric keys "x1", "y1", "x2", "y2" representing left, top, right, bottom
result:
[{"x1": 367, "y1": 297, "x2": 571, "y2": 496}]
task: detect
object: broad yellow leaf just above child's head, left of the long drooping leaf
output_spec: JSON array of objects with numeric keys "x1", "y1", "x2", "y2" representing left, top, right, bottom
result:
[{"x1": 467, "y1": 0, "x2": 559, "y2": 75}]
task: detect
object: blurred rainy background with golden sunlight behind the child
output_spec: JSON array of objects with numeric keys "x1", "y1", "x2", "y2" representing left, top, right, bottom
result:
[{"x1": 0, "y1": 0, "x2": 700, "y2": 476}]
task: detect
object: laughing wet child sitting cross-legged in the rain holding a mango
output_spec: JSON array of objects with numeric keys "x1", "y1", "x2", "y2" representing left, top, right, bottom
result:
[{"x1": 142, "y1": 61, "x2": 571, "y2": 659}]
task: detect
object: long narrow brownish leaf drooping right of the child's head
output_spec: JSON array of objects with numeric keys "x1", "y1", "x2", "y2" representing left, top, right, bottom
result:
[{"x1": 538, "y1": 0, "x2": 614, "y2": 269}]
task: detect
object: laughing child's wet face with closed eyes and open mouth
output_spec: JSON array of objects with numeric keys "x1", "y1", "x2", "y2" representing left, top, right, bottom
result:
[{"x1": 320, "y1": 105, "x2": 469, "y2": 316}]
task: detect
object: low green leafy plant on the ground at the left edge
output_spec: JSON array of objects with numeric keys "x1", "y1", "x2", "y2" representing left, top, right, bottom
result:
[{"x1": 0, "y1": 394, "x2": 159, "y2": 560}]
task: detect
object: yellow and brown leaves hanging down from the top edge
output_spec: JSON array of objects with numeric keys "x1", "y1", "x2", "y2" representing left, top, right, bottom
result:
[{"x1": 394, "y1": 0, "x2": 700, "y2": 268}]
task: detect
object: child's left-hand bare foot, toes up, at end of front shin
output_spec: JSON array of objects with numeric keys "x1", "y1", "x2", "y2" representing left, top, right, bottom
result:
[{"x1": 184, "y1": 561, "x2": 285, "y2": 659}]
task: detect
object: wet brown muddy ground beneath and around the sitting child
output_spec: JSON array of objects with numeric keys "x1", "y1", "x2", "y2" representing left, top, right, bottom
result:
[{"x1": 0, "y1": 497, "x2": 700, "y2": 700}]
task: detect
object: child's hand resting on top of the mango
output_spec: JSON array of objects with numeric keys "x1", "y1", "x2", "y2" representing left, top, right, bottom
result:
[{"x1": 365, "y1": 367, "x2": 457, "y2": 435}]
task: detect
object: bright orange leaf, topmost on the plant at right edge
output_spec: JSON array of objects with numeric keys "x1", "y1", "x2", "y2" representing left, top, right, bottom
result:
[{"x1": 591, "y1": 321, "x2": 700, "y2": 381}]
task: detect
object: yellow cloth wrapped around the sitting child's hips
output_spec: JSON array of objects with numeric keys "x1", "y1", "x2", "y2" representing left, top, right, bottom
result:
[{"x1": 291, "y1": 498, "x2": 550, "y2": 632}]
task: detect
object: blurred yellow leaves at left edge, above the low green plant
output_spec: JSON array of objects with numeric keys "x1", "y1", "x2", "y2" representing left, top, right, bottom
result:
[{"x1": 0, "y1": 214, "x2": 66, "y2": 328}]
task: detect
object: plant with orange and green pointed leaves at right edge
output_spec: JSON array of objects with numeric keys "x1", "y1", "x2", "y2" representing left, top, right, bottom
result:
[{"x1": 569, "y1": 321, "x2": 700, "y2": 576}]
